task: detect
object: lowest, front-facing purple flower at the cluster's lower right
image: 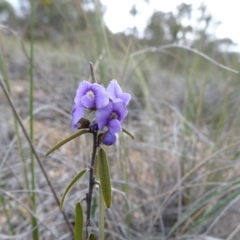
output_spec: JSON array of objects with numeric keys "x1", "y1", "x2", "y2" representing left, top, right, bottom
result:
[{"x1": 95, "y1": 99, "x2": 128, "y2": 145}]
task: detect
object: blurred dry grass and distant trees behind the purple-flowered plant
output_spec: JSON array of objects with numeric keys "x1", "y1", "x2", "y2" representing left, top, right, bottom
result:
[{"x1": 0, "y1": 0, "x2": 240, "y2": 240}]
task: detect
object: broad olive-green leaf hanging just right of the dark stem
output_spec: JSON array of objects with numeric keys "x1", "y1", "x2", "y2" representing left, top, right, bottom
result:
[{"x1": 98, "y1": 148, "x2": 112, "y2": 208}]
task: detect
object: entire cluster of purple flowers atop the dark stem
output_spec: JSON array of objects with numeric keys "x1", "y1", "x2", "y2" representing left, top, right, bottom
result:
[{"x1": 72, "y1": 80, "x2": 131, "y2": 145}]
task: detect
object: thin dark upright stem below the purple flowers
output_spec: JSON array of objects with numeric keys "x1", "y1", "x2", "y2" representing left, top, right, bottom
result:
[{"x1": 86, "y1": 131, "x2": 98, "y2": 238}]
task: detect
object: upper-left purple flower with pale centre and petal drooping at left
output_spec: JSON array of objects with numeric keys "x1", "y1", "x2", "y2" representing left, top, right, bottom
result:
[{"x1": 72, "y1": 81, "x2": 109, "y2": 129}]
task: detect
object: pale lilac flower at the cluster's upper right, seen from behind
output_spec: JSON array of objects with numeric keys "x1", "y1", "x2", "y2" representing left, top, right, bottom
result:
[{"x1": 106, "y1": 79, "x2": 131, "y2": 105}]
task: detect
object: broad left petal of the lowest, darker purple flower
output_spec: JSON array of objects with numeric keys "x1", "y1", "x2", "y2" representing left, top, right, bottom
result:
[{"x1": 95, "y1": 102, "x2": 113, "y2": 130}]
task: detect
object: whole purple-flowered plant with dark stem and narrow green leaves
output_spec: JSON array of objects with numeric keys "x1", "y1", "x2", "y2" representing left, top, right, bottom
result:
[{"x1": 46, "y1": 66, "x2": 133, "y2": 239}]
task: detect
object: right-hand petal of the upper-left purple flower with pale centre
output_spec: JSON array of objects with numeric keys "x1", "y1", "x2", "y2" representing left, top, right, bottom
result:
[{"x1": 92, "y1": 83, "x2": 109, "y2": 108}]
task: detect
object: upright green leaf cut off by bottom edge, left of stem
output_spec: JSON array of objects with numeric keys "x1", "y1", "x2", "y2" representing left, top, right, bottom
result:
[{"x1": 74, "y1": 202, "x2": 83, "y2": 240}]
